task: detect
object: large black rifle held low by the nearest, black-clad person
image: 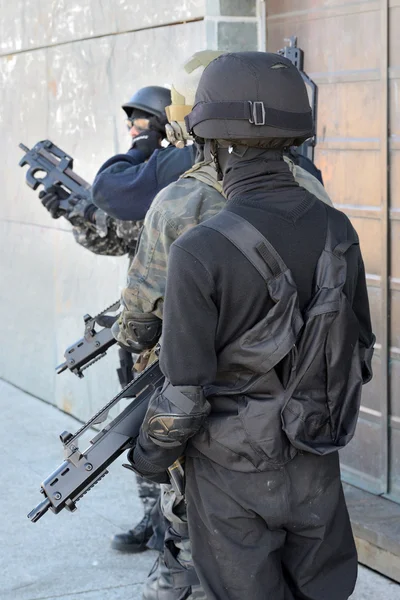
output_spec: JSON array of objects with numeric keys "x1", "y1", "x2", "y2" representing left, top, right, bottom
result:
[{"x1": 28, "y1": 361, "x2": 164, "y2": 523}]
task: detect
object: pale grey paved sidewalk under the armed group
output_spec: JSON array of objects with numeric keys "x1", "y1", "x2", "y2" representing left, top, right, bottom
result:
[{"x1": 0, "y1": 381, "x2": 400, "y2": 600}]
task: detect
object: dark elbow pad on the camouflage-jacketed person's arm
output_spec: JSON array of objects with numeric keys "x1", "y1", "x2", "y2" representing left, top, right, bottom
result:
[{"x1": 117, "y1": 311, "x2": 162, "y2": 354}]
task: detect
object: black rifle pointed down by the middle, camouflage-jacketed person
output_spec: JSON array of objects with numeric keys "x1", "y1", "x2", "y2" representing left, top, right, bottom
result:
[{"x1": 56, "y1": 301, "x2": 120, "y2": 377}]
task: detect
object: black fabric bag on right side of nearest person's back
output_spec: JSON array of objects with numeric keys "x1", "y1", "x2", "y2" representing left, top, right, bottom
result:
[{"x1": 281, "y1": 293, "x2": 362, "y2": 455}]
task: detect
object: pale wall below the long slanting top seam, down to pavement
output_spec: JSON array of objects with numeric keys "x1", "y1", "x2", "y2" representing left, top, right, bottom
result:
[{"x1": 0, "y1": 19, "x2": 205, "y2": 419}]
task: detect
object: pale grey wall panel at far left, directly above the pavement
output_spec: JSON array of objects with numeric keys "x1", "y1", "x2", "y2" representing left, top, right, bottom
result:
[{"x1": 0, "y1": 222, "x2": 57, "y2": 401}]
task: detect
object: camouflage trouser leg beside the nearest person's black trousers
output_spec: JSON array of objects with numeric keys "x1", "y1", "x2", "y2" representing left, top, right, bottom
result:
[{"x1": 160, "y1": 484, "x2": 207, "y2": 600}]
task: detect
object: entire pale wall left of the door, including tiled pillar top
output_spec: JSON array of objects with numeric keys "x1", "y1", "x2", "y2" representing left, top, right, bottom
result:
[{"x1": 0, "y1": 0, "x2": 259, "y2": 419}]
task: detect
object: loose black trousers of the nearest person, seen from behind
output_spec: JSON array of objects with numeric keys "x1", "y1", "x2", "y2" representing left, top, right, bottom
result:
[{"x1": 186, "y1": 452, "x2": 357, "y2": 600}]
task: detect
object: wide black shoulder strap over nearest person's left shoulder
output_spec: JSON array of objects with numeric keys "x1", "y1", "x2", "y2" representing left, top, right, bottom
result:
[{"x1": 200, "y1": 210, "x2": 288, "y2": 282}]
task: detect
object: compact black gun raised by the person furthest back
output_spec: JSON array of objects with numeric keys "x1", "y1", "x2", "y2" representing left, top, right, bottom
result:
[{"x1": 19, "y1": 140, "x2": 95, "y2": 228}]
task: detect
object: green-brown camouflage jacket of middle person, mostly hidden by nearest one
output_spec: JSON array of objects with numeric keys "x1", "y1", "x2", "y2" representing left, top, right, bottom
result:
[{"x1": 114, "y1": 157, "x2": 332, "y2": 345}]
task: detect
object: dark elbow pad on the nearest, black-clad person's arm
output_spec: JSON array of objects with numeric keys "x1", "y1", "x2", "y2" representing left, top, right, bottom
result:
[{"x1": 143, "y1": 381, "x2": 211, "y2": 448}]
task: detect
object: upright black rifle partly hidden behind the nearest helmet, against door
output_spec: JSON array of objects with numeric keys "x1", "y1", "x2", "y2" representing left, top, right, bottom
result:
[{"x1": 278, "y1": 36, "x2": 318, "y2": 162}]
